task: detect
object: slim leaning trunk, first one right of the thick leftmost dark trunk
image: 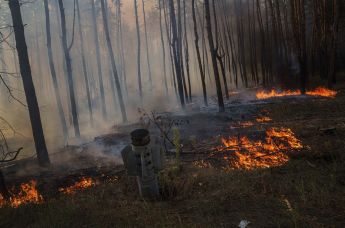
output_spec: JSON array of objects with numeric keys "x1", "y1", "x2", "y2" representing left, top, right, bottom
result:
[{"x1": 44, "y1": 0, "x2": 68, "y2": 143}]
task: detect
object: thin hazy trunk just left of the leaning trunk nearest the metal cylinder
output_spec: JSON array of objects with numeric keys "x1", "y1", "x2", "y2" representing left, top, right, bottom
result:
[{"x1": 90, "y1": 0, "x2": 107, "y2": 119}]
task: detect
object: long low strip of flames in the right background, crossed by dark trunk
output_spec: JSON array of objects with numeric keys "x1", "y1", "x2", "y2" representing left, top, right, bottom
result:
[{"x1": 256, "y1": 87, "x2": 337, "y2": 100}]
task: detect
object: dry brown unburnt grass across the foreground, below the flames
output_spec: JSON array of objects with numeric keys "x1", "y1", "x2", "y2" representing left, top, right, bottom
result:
[{"x1": 0, "y1": 90, "x2": 345, "y2": 227}]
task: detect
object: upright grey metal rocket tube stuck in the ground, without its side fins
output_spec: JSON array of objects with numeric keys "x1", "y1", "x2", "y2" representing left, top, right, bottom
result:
[{"x1": 131, "y1": 129, "x2": 159, "y2": 199}]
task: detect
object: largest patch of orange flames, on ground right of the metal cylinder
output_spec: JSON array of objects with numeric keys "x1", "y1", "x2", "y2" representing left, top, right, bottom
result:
[{"x1": 217, "y1": 128, "x2": 303, "y2": 170}]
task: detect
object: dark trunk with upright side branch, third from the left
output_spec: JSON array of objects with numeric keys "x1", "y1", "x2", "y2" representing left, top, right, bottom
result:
[{"x1": 58, "y1": 0, "x2": 80, "y2": 138}]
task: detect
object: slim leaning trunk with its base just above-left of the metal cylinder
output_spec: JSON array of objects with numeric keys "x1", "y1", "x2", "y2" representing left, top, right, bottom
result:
[{"x1": 101, "y1": 0, "x2": 127, "y2": 122}]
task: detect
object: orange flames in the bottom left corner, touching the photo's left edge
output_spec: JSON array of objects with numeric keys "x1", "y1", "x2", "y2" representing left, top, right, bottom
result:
[{"x1": 0, "y1": 180, "x2": 43, "y2": 208}]
